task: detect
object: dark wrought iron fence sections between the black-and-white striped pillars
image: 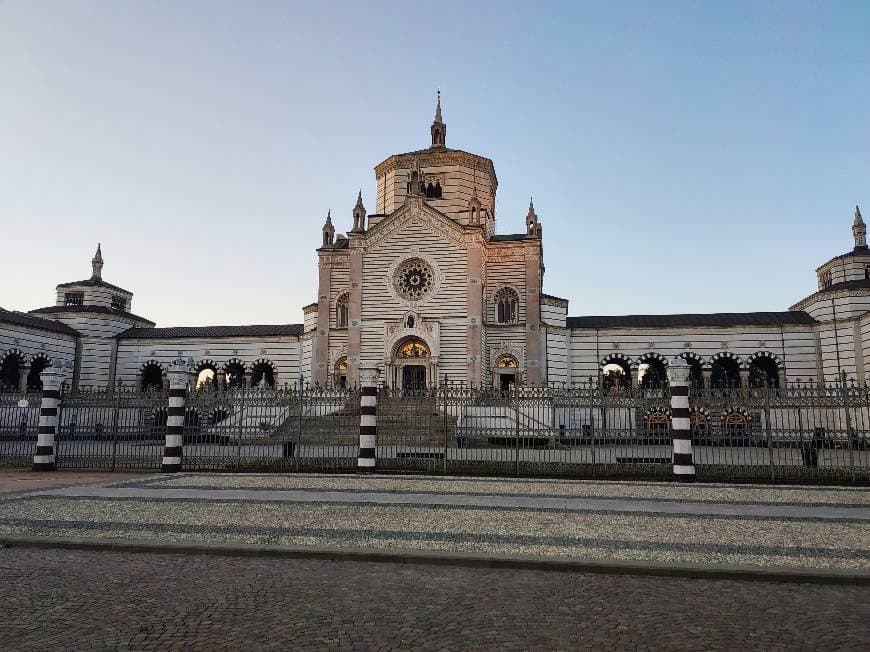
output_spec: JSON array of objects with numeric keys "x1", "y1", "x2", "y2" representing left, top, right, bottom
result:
[{"x1": 0, "y1": 379, "x2": 870, "y2": 482}]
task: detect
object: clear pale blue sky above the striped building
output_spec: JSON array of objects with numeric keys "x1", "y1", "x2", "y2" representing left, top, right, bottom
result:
[{"x1": 0, "y1": 0, "x2": 870, "y2": 326}]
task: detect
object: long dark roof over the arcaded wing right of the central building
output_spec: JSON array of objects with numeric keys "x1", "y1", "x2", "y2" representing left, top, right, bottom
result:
[{"x1": 567, "y1": 310, "x2": 816, "y2": 328}]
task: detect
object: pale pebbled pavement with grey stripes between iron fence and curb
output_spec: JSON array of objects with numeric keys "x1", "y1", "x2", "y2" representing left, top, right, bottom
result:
[{"x1": 0, "y1": 473, "x2": 870, "y2": 571}]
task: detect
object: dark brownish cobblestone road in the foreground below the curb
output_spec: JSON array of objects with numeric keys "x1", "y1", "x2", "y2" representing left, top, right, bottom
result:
[{"x1": 0, "y1": 548, "x2": 870, "y2": 650}]
